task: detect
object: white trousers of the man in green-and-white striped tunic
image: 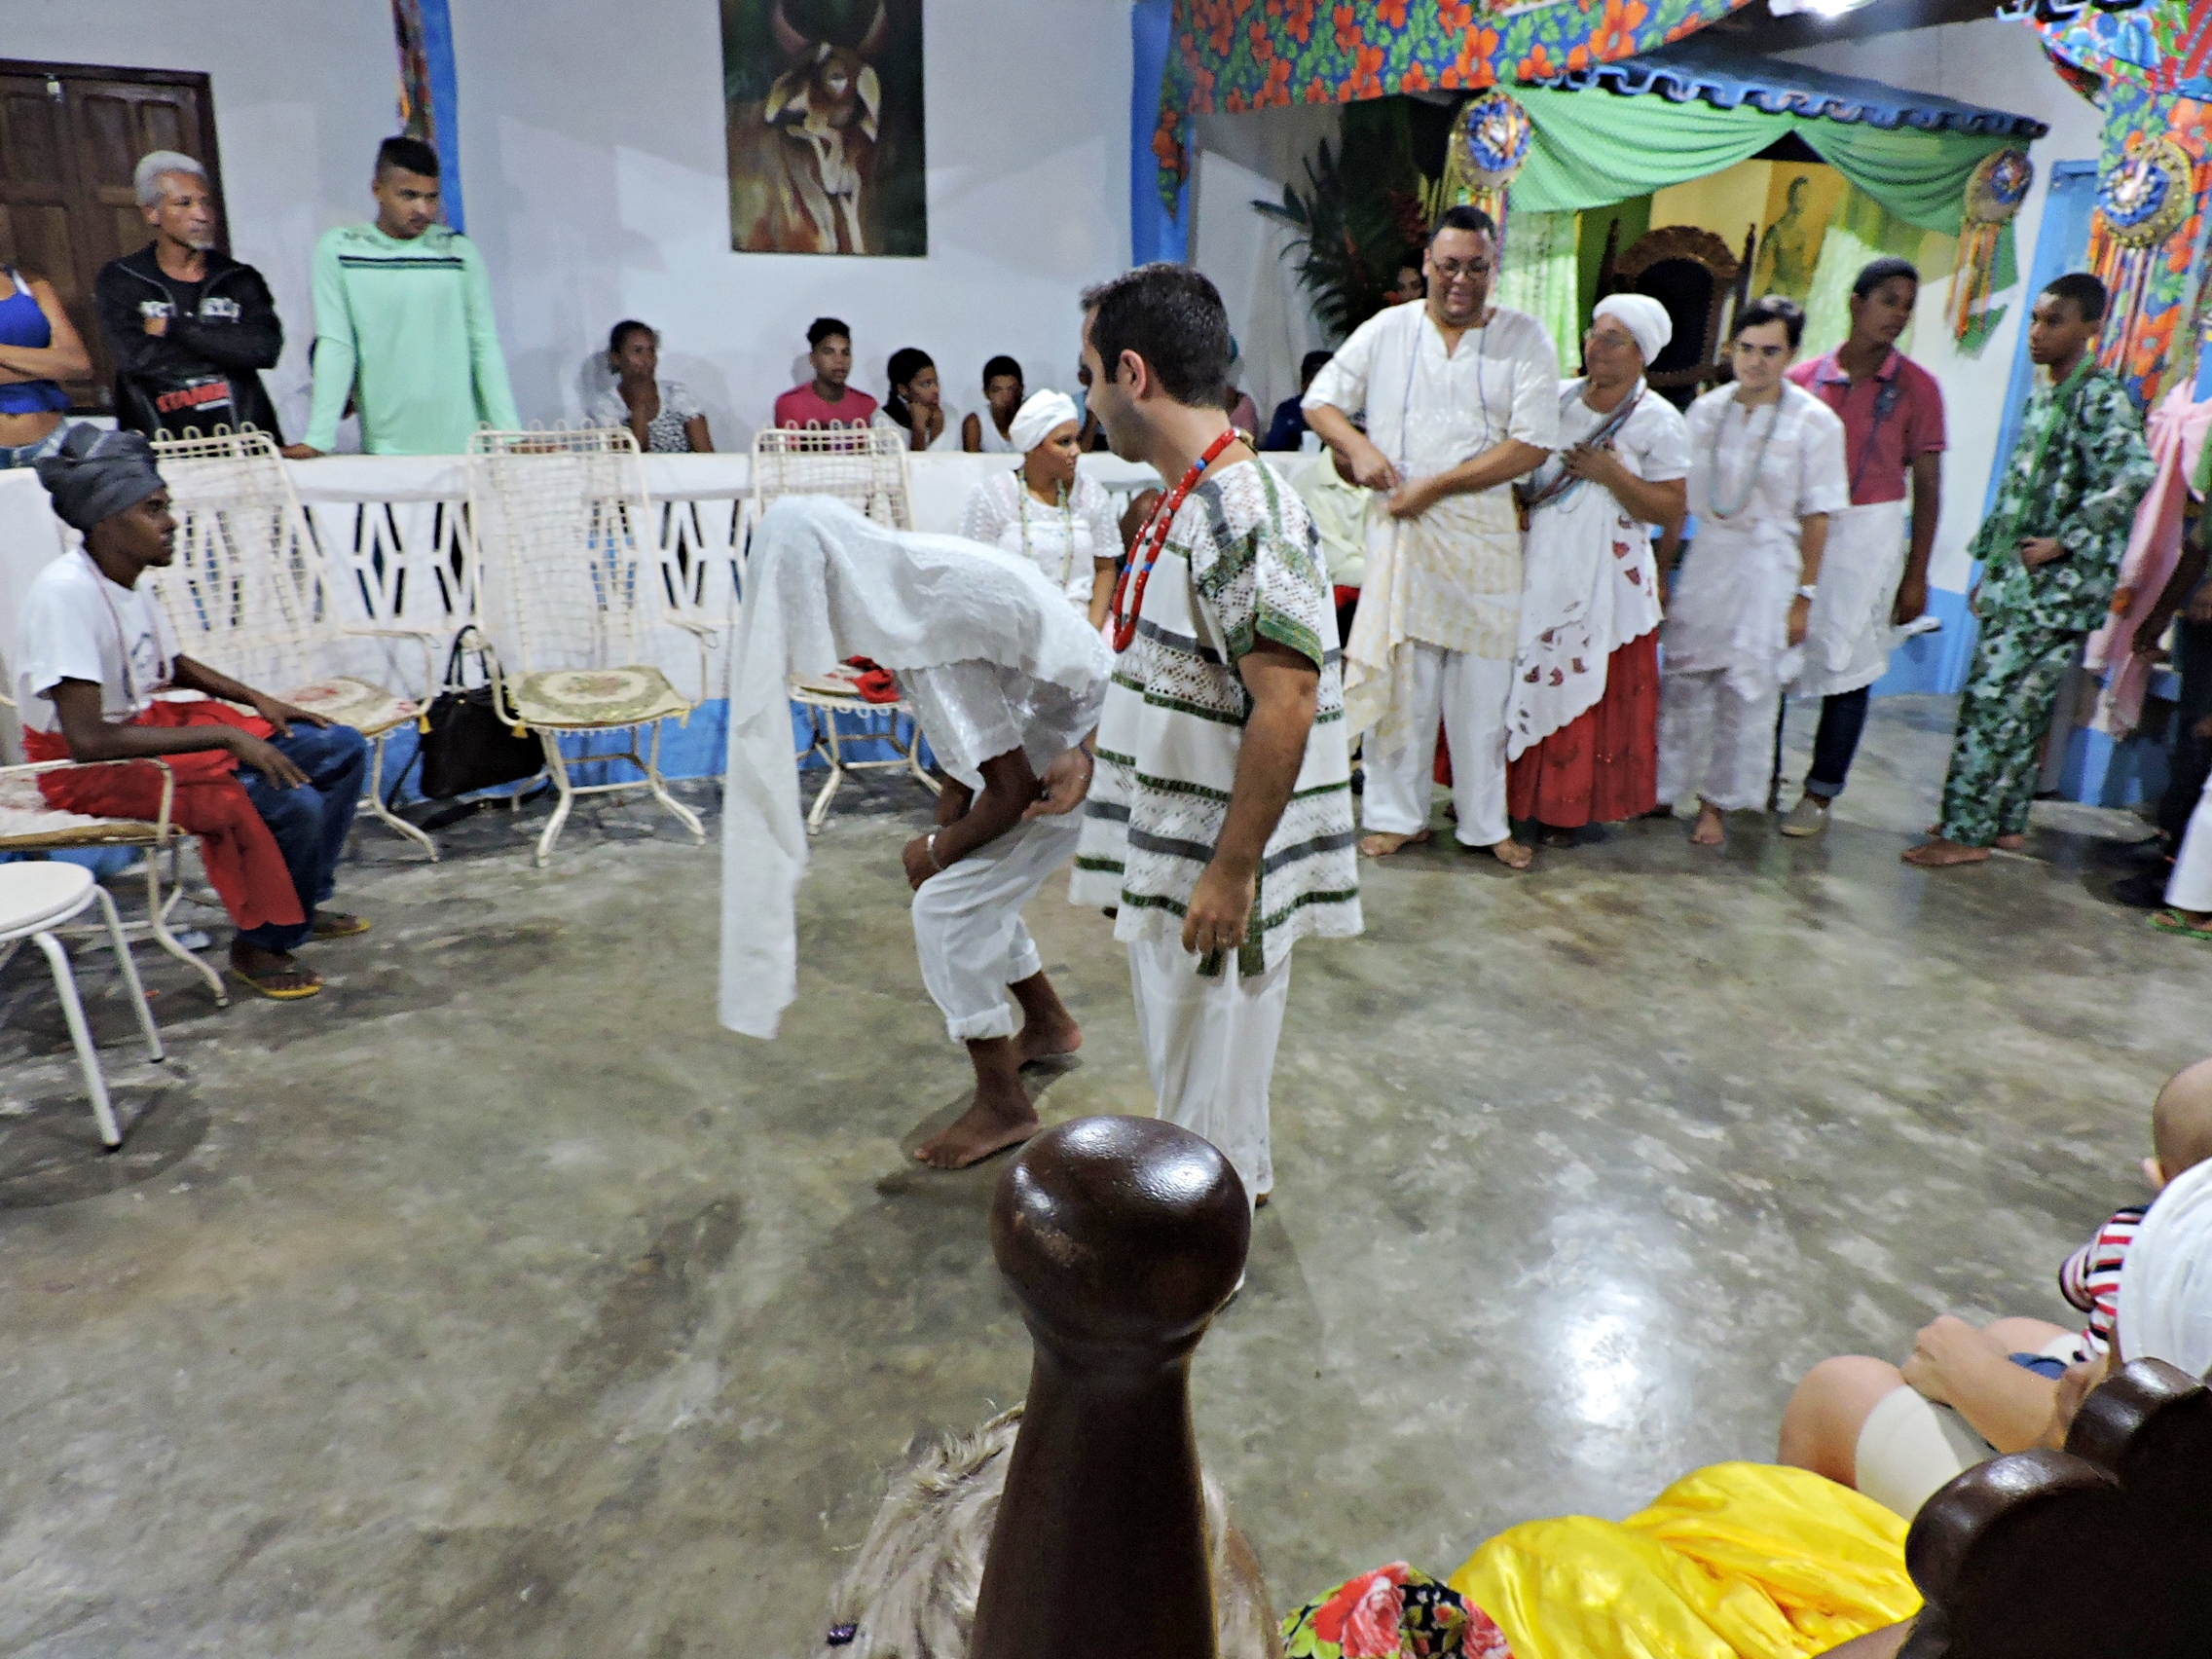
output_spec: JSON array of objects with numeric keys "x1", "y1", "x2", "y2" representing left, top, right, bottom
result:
[{"x1": 1128, "y1": 936, "x2": 1290, "y2": 1203}]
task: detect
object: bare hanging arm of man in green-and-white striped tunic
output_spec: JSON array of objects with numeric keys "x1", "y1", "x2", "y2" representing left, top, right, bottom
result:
[{"x1": 1184, "y1": 640, "x2": 1320, "y2": 953}]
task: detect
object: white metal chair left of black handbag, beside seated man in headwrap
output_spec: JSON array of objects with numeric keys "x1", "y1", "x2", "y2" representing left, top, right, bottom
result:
[{"x1": 146, "y1": 426, "x2": 438, "y2": 859}]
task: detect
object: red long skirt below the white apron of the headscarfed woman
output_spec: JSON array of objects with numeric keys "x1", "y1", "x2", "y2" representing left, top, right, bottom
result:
[{"x1": 1506, "y1": 628, "x2": 1659, "y2": 830}]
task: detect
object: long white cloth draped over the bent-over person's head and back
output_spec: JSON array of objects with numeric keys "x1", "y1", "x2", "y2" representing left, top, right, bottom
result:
[{"x1": 719, "y1": 496, "x2": 1108, "y2": 1038}]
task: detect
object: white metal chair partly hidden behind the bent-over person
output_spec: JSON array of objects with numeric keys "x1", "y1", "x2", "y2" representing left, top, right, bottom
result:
[{"x1": 752, "y1": 426, "x2": 938, "y2": 834}]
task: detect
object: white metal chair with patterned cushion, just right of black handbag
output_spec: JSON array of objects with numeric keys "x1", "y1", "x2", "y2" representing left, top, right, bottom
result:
[{"x1": 469, "y1": 426, "x2": 715, "y2": 865}]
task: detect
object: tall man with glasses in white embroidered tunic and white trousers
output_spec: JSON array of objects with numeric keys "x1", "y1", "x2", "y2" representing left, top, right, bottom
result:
[{"x1": 1305, "y1": 208, "x2": 1560, "y2": 869}]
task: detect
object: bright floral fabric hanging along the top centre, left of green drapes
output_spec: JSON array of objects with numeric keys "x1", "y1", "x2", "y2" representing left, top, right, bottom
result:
[{"x1": 1153, "y1": 0, "x2": 1746, "y2": 208}]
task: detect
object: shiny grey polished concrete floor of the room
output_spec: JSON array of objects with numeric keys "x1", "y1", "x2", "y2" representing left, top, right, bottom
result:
[{"x1": 0, "y1": 699, "x2": 2212, "y2": 1659}]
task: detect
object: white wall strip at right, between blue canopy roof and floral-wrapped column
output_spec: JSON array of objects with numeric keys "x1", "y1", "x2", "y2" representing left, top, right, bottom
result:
[{"x1": 1788, "y1": 18, "x2": 2101, "y2": 591}]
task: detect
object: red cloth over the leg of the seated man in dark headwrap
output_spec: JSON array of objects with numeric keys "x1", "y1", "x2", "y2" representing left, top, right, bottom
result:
[{"x1": 22, "y1": 697, "x2": 308, "y2": 929}]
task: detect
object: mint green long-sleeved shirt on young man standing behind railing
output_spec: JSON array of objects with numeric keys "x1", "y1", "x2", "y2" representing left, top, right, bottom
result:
[{"x1": 306, "y1": 223, "x2": 522, "y2": 456}]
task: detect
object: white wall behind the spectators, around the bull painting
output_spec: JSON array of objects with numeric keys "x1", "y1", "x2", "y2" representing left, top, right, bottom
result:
[{"x1": 0, "y1": 0, "x2": 1130, "y2": 449}]
